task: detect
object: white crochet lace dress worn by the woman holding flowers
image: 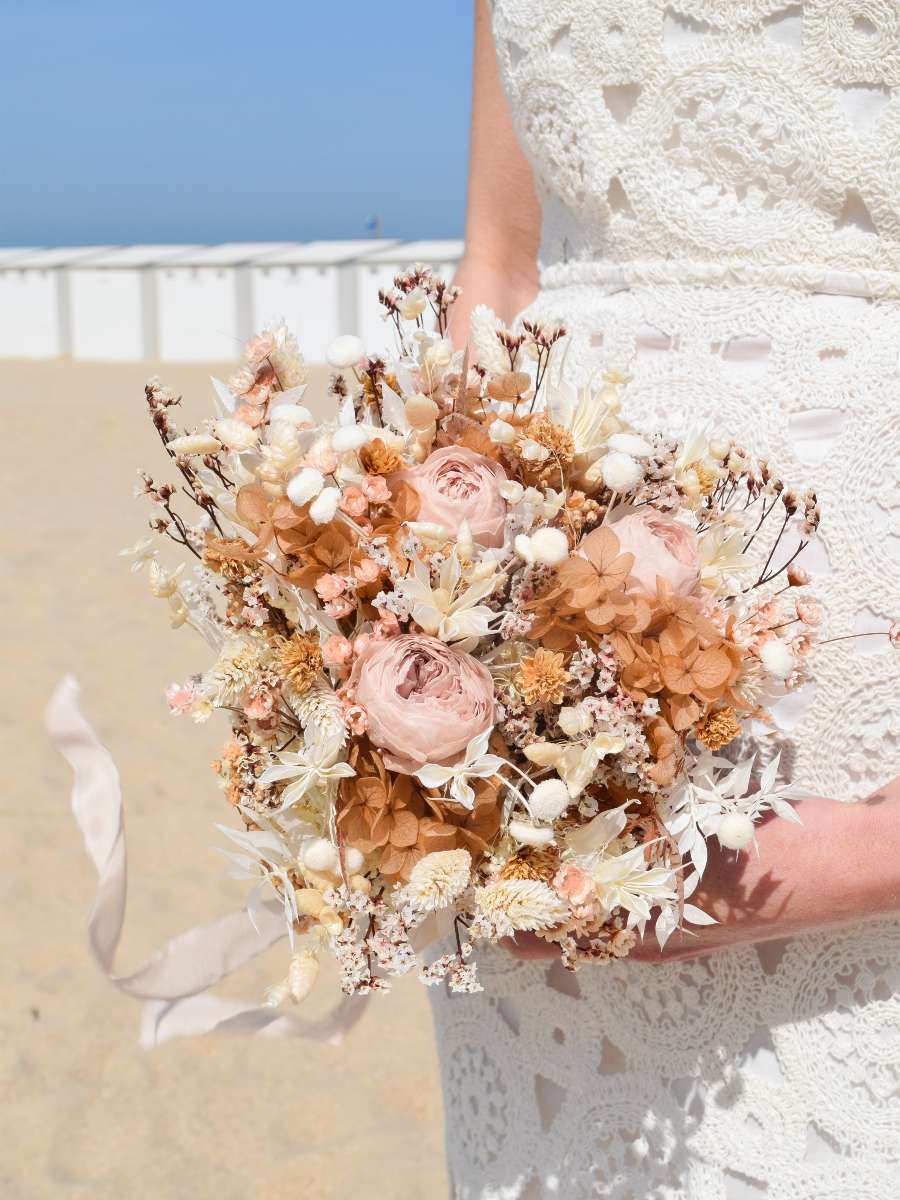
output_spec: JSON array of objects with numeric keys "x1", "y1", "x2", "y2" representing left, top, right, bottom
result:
[{"x1": 433, "y1": 0, "x2": 900, "y2": 1200}]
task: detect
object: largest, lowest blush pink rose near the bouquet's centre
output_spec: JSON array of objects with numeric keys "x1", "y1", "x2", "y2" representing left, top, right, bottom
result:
[{"x1": 348, "y1": 634, "x2": 494, "y2": 775}]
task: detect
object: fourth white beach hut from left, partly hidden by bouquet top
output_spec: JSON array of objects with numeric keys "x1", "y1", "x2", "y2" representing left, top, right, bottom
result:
[{"x1": 252, "y1": 238, "x2": 392, "y2": 362}]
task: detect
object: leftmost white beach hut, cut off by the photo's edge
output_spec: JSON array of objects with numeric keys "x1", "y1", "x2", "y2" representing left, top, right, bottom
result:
[{"x1": 0, "y1": 246, "x2": 112, "y2": 359}]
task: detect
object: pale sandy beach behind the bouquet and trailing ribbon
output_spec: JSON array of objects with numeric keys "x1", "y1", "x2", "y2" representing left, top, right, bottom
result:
[{"x1": 0, "y1": 361, "x2": 446, "y2": 1200}]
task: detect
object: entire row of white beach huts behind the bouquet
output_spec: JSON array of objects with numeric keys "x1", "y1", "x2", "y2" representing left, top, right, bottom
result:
[{"x1": 0, "y1": 239, "x2": 462, "y2": 362}]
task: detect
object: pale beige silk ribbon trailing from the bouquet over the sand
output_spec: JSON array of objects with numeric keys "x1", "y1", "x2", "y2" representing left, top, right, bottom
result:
[{"x1": 47, "y1": 676, "x2": 366, "y2": 1048}]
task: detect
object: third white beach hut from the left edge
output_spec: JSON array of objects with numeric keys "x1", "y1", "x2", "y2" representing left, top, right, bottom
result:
[{"x1": 154, "y1": 241, "x2": 290, "y2": 362}]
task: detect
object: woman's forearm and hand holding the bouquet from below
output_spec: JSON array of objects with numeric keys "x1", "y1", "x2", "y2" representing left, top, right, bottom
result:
[{"x1": 510, "y1": 779, "x2": 900, "y2": 962}]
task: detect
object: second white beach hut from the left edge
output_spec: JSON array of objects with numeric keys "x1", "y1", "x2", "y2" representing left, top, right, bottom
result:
[{"x1": 68, "y1": 245, "x2": 203, "y2": 362}]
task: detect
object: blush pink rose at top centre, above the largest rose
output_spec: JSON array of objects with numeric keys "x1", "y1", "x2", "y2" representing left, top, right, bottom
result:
[{"x1": 394, "y1": 446, "x2": 506, "y2": 546}]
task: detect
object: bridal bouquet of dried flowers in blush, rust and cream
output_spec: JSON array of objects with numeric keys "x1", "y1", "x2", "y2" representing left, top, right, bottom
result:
[{"x1": 130, "y1": 268, "x2": 820, "y2": 1004}]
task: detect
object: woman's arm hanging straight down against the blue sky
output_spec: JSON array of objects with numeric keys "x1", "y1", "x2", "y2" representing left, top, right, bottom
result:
[{"x1": 450, "y1": 0, "x2": 541, "y2": 346}]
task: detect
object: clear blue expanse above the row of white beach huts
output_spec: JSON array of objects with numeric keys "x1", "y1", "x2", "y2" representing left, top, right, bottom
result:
[{"x1": 0, "y1": 0, "x2": 472, "y2": 246}]
